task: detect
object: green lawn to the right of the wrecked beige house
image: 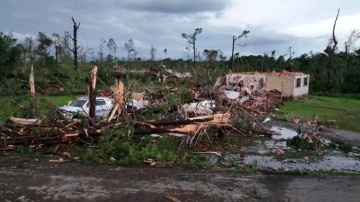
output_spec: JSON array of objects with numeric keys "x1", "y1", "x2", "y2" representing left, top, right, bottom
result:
[{"x1": 278, "y1": 96, "x2": 360, "y2": 132}]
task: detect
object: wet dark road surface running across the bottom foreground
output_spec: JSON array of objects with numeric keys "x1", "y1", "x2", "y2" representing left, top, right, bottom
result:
[{"x1": 0, "y1": 155, "x2": 360, "y2": 202}]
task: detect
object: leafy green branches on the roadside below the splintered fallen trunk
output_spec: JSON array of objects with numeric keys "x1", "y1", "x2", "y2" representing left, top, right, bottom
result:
[{"x1": 86, "y1": 124, "x2": 180, "y2": 165}]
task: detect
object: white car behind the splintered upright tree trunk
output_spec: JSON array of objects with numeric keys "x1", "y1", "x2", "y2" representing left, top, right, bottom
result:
[{"x1": 59, "y1": 97, "x2": 114, "y2": 119}]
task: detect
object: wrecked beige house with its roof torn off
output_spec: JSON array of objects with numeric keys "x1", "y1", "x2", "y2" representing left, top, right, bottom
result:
[{"x1": 214, "y1": 71, "x2": 310, "y2": 98}]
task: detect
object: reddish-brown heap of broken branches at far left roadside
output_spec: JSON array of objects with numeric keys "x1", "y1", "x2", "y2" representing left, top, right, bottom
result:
[{"x1": 0, "y1": 117, "x2": 100, "y2": 150}]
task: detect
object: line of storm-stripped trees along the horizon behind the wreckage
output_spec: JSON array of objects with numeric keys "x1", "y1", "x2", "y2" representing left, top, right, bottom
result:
[{"x1": 0, "y1": 11, "x2": 360, "y2": 95}]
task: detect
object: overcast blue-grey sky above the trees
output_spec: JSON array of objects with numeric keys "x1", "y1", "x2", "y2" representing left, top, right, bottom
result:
[{"x1": 0, "y1": 0, "x2": 360, "y2": 60}]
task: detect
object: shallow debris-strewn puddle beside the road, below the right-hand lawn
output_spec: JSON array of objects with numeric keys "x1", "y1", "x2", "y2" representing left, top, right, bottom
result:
[{"x1": 202, "y1": 126, "x2": 360, "y2": 172}]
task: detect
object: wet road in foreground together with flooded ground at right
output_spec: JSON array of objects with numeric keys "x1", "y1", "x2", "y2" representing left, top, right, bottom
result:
[{"x1": 0, "y1": 120, "x2": 360, "y2": 202}]
